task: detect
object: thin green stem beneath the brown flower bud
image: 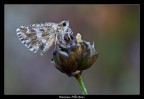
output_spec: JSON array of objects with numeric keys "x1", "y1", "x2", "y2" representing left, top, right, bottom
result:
[{"x1": 75, "y1": 74, "x2": 88, "y2": 95}]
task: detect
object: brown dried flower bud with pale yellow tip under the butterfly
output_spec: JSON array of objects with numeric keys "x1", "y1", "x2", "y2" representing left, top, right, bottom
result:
[{"x1": 52, "y1": 33, "x2": 98, "y2": 76}]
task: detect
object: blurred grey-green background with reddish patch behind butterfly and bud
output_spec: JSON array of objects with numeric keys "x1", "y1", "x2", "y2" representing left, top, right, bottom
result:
[{"x1": 4, "y1": 4, "x2": 140, "y2": 95}]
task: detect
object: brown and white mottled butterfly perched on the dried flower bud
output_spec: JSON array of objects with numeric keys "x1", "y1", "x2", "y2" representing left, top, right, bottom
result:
[{"x1": 16, "y1": 21, "x2": 73, "y2": 55}]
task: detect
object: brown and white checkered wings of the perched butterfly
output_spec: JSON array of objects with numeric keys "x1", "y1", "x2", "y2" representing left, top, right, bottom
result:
[{"x1": 16, "y1": 23, "x2": 55, "y2": 53}]
